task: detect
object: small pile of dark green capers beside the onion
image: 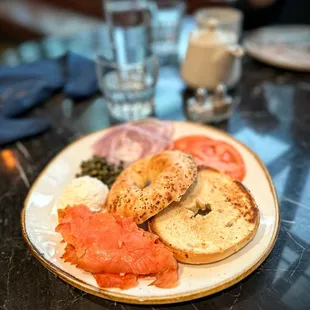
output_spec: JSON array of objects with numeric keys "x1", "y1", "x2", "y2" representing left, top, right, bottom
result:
[{"x1": 76, "y1": 155, "x2": 124, "y2": 188}]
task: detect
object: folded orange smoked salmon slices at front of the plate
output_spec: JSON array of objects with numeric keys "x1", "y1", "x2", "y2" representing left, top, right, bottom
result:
[{"x1": 56, "y1": 205, "x2": 179, "y2": 289}]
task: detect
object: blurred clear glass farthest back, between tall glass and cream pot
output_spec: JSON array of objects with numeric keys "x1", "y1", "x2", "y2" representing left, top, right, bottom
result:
[{"x1": 151, "y1": 0, "x2": 185, "y2": 60}]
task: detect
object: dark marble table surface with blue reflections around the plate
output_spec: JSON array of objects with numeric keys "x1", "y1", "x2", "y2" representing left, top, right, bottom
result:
[{"x1": 0, "y1": 17, "x2": 310, "y2": 310}]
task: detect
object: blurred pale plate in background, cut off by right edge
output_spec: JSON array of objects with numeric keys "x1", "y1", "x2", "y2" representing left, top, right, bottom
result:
[{"x1": 244, "y1": 25, "x2": 310, "y2": 71}]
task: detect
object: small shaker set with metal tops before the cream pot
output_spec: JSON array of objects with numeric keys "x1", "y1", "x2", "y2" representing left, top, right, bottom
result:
[{"x1": 186, "y1": 84, "x2": 233, "y2": 123}]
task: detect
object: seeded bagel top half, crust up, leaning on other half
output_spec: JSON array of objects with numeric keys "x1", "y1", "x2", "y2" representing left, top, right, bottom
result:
[{"x1": 106, "y1": 151, "x2": 197, "y2": 224}]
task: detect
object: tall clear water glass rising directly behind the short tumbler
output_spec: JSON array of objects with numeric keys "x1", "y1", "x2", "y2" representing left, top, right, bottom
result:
[{"x1": 103, "y1": 0, "x2": 151, "y2": 64}]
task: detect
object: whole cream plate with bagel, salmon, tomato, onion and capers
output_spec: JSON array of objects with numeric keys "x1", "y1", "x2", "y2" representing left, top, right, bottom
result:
[{"x1": 21, "y1": 119, "x2": 279, "y2": 304}]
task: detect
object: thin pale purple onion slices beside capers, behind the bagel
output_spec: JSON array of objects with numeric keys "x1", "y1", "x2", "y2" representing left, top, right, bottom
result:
[{"x1": 93, "y1": 119, "x2": 173, "y2": 166}]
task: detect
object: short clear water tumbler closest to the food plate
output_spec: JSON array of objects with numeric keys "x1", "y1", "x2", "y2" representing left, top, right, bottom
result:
[{"x1": 96, "y1": 55, "x2": 158, "y2": 122}]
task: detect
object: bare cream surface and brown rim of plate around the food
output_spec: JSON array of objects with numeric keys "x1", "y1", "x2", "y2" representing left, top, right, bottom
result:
[{"x1": 22, "y1": 122, "x2": 279, "y2": 304}]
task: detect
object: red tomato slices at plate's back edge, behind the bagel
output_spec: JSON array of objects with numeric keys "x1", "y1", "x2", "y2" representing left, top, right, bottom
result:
[{"x1": 174, "y1": 135, "x2": 245, "y2": 181}]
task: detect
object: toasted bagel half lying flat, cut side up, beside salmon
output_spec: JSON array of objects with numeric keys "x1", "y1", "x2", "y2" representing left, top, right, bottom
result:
[{"x1": 148, "y1": 167, "x2": 259, "y2": 264}]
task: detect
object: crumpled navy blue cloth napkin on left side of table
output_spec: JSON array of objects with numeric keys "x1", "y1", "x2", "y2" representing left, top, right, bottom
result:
[{"x1": 0, "y1": 53, "x2": 98, "y2": 145}]
